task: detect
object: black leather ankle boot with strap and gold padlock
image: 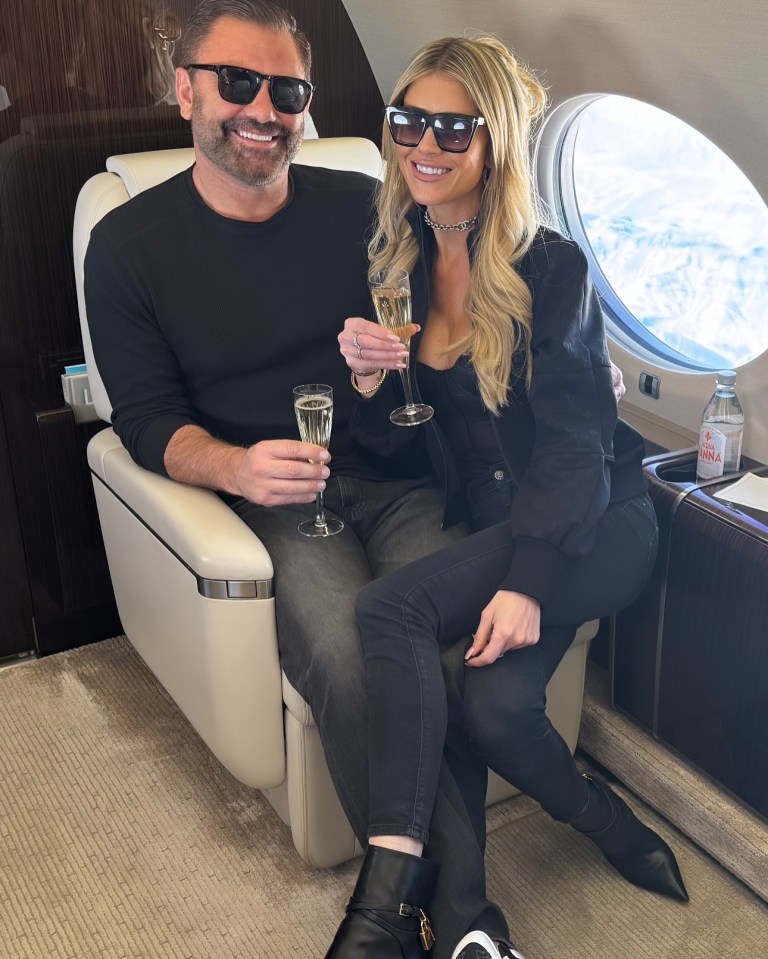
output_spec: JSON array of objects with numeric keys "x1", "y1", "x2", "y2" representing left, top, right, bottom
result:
[{"x1": 325, "y1": 846, "x2": 440, "y2": 959}]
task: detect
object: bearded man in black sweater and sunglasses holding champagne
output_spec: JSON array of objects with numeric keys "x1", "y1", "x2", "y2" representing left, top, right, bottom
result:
[{"x1": 85, "y1": 0, "x2": 507, "y2": 959}]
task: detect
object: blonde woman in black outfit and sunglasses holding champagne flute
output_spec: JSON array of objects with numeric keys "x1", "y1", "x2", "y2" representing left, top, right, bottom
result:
[{"x1": 329, "y1": 38, "x2": 687, "y2": 959}]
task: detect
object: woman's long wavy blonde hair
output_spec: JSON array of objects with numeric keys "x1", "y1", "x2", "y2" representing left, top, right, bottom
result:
[{"x1": 368, "y1": 36, "x2": 547, "y2": 414}]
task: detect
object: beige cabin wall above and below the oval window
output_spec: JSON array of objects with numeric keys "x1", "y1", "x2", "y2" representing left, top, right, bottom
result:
[{"x1": 344, "y1": 0, "x2": 768, "y2": 463}]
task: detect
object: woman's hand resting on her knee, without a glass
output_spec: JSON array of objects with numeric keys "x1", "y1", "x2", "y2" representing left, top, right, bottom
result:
[{"x1": 464, "y1": 589, "x2": 541, "y2": 666}]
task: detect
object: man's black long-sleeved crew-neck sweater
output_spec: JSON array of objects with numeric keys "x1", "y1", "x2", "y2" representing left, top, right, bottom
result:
[{"x1": 85, "y1": 166, "x2": 392, "y2": 478}]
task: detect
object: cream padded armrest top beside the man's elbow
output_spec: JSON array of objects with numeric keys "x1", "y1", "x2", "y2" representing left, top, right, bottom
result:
[{"x1": 88, "y1": 429, "x2": 272, "y2": 581}]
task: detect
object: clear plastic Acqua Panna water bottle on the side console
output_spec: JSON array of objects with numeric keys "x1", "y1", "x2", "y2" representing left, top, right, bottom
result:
[{"x1": 696, "y1": 370, "x2": 744, "y2": 482}]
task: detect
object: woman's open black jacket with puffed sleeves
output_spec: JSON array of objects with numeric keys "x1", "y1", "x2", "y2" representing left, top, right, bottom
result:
[{"x1": 351, "y1": 209, "x2": 645, "y2": 602}]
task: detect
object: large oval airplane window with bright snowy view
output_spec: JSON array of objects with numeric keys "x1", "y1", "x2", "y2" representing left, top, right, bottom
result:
[{"x1": 536, "y1": 95, "x2": 768, "y2": 370}]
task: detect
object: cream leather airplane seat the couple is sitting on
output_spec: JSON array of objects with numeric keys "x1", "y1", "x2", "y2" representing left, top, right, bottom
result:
[{"x1": 74, "y1": 137, "x2": 597, "y2": 867}]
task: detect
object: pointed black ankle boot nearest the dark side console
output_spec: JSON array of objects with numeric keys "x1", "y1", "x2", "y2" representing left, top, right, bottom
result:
[{"x1": 571, "y1": 776, "x2": 688, "y2": 902}]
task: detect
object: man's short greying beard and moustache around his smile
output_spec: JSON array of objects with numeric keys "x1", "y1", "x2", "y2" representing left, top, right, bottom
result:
[{"x1": 192, "y1": 109, "x2": 304, "y2": 187}]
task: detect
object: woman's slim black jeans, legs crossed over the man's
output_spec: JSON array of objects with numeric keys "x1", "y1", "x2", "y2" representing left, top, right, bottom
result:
[{"x1": 357, "y1": 494, "x2": 658, "y2": 842}]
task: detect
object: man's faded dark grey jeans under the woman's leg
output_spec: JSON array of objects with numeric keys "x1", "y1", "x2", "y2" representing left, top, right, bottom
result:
[{"x1": 234, "y1": 476, "x2": 508, "y2": 959}]
